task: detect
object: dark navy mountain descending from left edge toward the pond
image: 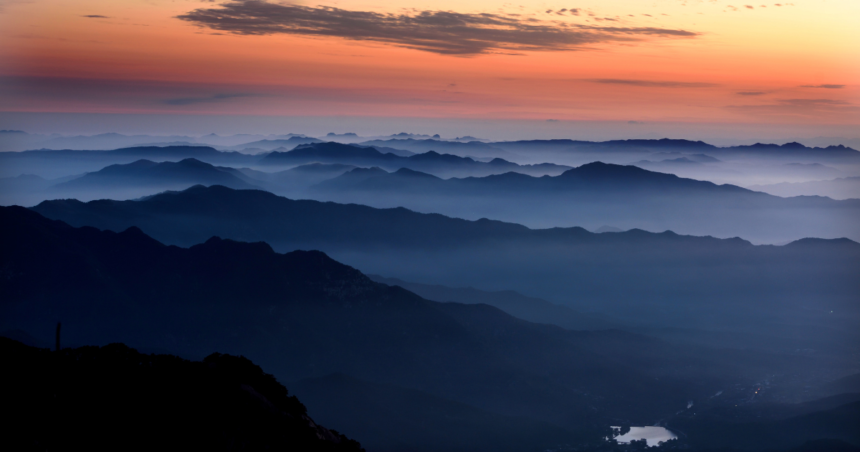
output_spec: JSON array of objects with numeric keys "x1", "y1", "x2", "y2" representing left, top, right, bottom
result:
[{"x1": 5, "y1": 206, "x2": 852, "y2": 450}]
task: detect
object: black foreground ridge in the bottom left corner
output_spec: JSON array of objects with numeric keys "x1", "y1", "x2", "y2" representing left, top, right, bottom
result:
[{"x1": 0, "y1": 337, "x2": 363, "y2": 452}]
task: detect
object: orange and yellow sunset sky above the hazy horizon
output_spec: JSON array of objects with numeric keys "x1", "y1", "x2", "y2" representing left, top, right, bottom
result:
[{"x1": 0, "y1": 0, "x2": 860, "y2": 135}]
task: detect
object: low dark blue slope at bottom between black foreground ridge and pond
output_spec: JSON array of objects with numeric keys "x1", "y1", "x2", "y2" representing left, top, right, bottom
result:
[{"x1": 291, "y1": 374, "x2": 570, "y2": 452}]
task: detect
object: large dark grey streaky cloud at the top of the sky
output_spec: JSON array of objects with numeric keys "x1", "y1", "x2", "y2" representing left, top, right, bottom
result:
[{"x1": 177, "y1": 0, "x2": 699, "y2": 55}]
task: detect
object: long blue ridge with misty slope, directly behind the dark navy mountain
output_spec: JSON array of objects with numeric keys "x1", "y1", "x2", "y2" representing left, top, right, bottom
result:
[{"x1": 28, "y1": 186, "x2": 860, "y2": 356}]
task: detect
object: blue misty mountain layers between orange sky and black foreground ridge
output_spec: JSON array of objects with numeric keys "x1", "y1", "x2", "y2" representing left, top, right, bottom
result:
[{"x1": 0, "y1": 130, "x2": 860, "y2": 452}]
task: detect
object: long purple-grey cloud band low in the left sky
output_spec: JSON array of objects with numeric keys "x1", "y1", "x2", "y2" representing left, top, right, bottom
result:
[{"x1": 0, "y1": 75, "x2": 478, "y2": 114}]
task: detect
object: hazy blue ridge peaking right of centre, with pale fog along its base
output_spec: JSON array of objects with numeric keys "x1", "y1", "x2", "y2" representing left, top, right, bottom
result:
[{"x1": 308, "y1": 162, "x2": 860, "y2": 243}]
